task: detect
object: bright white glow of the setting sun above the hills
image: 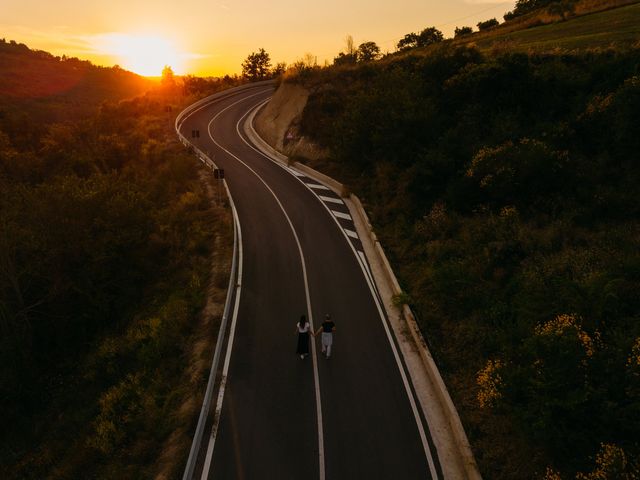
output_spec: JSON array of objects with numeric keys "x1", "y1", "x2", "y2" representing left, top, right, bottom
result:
[{"x1": 96, "y1": 33, "x2": 183, "y2": 77}]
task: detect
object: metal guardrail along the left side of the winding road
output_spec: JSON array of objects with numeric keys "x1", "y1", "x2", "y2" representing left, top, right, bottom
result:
[{"x1": 175, "y1": 80, "x2": 273, "y2": 480}]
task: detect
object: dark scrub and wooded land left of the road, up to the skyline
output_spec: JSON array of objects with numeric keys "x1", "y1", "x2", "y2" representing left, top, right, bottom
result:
[{"x1": 0, "y1": 42, "x2": 237, "y2": 479}]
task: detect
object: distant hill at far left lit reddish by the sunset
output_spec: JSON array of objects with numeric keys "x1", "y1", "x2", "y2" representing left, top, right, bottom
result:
[{"x1": 0, "y1": 39, "x2": 154, "y2": 125}]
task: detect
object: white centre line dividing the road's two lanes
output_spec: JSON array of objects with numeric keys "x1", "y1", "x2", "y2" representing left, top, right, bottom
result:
[{"x1": 202, "y1": 92, "x2": 325, "y2": 480}]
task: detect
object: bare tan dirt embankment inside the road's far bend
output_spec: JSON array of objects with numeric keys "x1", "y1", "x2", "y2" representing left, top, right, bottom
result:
[{"x1": 255, "y1": 79, "x2": 326, "y2": 160}]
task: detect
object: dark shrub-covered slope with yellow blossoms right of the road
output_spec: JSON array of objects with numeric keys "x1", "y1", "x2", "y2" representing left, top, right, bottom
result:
[{"x1": 278, "y1": 2, "x2": 640, "y2": 480}]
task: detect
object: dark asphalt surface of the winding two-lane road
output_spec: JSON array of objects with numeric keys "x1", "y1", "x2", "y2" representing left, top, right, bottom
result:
[{"x1": 181, "y1": 86, "x2": 442, "y2": 480}]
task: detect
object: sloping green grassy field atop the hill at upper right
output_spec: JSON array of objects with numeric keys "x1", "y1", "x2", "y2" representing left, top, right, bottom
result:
[{"x1": 456, "y1": 3, "x2": 640, "y2": 51}]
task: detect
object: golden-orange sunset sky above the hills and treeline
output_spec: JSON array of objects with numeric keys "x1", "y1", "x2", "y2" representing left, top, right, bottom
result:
[{"x1": 0, "y1": 0, "x2": 515, "y2": 76}]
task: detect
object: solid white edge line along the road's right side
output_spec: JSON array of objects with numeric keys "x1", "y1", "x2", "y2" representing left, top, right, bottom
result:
[{"x1": 241, "y1": 101, "x2": 438, "y2": 479}]
